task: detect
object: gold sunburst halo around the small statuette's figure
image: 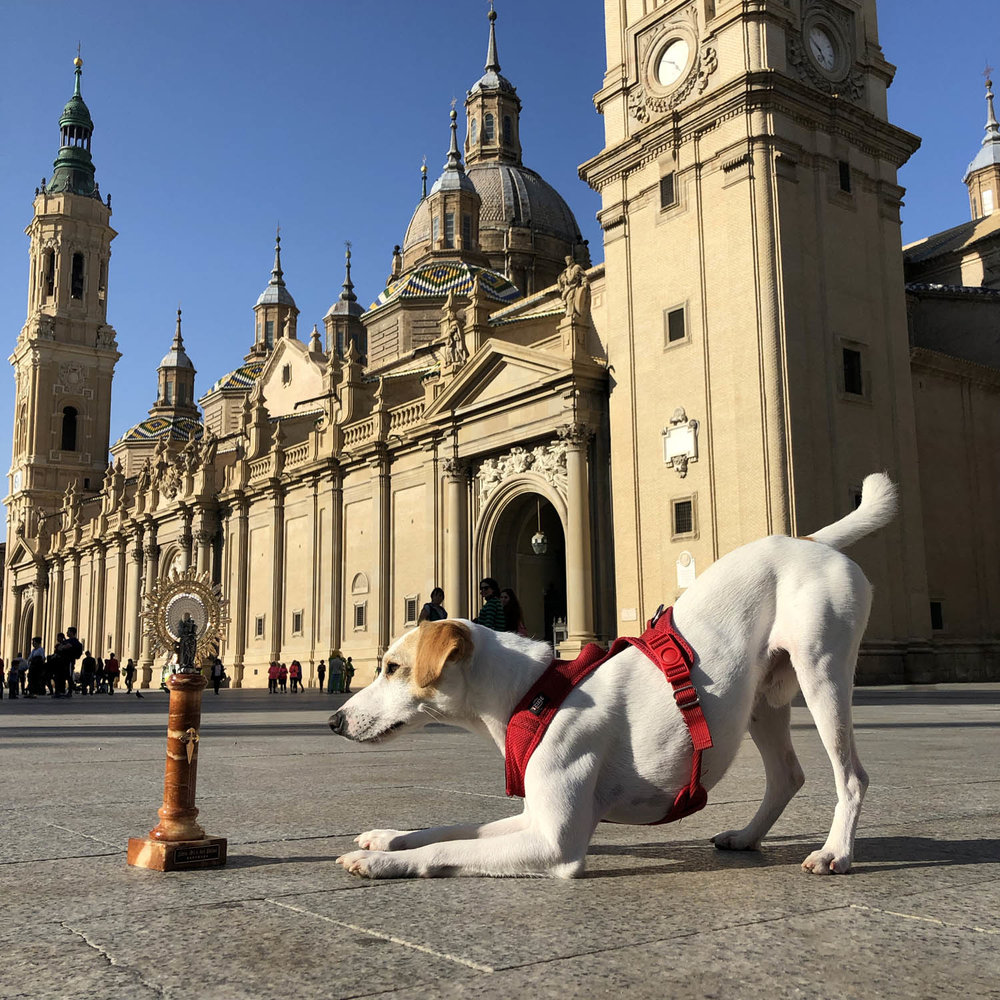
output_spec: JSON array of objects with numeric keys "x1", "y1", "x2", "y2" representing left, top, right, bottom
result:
[{"x1": 142, "y1": 569, "x2": 229, "y2": 666}]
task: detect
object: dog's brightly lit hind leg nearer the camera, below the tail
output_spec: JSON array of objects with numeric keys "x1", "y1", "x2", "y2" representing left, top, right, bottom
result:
[{"x1": 796, "y1": 643, "x2": 868, "y2": 875}]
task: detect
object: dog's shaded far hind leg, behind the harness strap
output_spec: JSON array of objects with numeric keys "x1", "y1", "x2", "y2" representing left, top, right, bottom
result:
[{"x1": 712, "y1": 699, "x2": 805, "y2": 851}]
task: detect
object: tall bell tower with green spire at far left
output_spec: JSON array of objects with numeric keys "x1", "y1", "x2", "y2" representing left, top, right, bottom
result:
[{"x1": 7, "y1": 56, "x2": 121, "y2": 534}]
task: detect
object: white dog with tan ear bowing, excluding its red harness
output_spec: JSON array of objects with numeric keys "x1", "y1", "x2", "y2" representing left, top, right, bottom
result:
[{"x1": 330, "y1": 474, "x2": 896, "y2": 878}]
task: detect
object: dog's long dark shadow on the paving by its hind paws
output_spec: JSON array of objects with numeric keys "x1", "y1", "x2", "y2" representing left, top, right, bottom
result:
[{"x1": 585, "y1": 834, "x2": 1000, "y2": 878}]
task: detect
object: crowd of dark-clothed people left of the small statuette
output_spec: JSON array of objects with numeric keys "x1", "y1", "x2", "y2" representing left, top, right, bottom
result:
[{"x1": 0, "y1": 626, "x2": 143, "y2": 700}]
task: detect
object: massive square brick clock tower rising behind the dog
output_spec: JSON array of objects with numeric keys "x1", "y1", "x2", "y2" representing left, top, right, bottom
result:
[{"x1": 581, "y1": 0, "x2": 930, "y2": 666}]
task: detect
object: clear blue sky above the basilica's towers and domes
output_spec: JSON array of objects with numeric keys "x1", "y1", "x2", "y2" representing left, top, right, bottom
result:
[{"x1": 0, "y1": 0, "x2": 1000, "y2": 544}]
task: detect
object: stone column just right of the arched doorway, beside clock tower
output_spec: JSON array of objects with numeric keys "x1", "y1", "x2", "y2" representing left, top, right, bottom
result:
[{"x1": 558, "y1": 424, "x2": 595, "y2": 656}]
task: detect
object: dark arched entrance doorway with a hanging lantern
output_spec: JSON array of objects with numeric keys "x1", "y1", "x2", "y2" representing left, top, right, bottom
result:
[{"x1": 481, "y1": 492, "x2": 566, "y2": 642}]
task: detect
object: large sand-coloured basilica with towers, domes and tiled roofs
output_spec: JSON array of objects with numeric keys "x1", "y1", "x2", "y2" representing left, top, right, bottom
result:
[{"x1": 7, "y1": 0, "x2": 1000, "y2": 687}]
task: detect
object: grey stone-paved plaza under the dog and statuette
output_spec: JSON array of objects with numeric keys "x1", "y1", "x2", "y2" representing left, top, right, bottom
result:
[{"x1": 0, "y1": 685, "x2": 1000, "y2": 1000}]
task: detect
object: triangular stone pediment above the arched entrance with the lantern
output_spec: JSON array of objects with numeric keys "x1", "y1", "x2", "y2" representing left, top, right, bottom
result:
[{"x1": 424, "y1": 340, "x2": 571, "y2": 419}]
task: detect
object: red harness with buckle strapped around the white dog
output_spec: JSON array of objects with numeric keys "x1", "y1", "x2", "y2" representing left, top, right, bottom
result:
[{"x1": 505, "y1": 605, "x2": 712, "y2": 826}]
